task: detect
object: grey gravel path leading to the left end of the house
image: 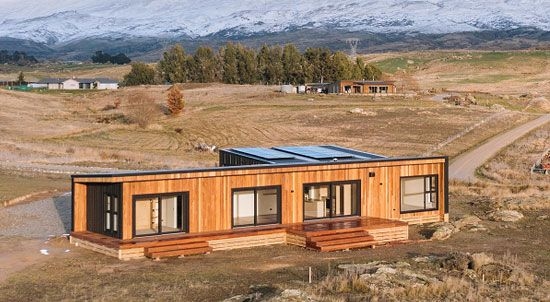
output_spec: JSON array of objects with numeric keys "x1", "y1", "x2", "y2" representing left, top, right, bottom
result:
[{"x1": 0, "y1": 192, "x2": 71, "y2": 238}]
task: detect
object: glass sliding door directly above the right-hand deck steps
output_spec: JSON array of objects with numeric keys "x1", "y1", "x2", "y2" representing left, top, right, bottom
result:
[{"x1": 304, "y1": 181, "x2": 361, "y2": 220}]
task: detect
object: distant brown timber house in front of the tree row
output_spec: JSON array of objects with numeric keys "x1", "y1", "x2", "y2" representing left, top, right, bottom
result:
[{"x1": 328, "y1": 80, "x2": 397, "y2": 94}]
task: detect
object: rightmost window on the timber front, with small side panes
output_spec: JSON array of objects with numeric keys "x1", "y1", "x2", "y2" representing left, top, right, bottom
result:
[{"x1": 401, "y1": 175, "x2": 438, "y2": 213}]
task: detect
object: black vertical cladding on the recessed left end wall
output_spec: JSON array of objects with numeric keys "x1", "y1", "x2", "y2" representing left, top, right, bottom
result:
[{"x1": 86, "y1": 183, "x2": 124, "y2": 237}]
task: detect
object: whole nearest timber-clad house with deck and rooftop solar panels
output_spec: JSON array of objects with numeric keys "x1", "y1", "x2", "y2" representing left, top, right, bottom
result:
[{"x1": 71, "y1": 146, "x2": 448, "y2": 259}]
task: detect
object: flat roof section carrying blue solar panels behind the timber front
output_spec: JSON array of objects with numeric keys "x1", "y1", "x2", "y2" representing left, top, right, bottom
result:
[{"x1": 220, "y1": 145, "x2": 386, "y2": 164}]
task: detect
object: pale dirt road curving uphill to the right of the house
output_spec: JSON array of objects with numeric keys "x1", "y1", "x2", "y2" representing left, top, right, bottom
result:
[{"x1": 449, "y1": 114, "x2": 550, "y2": 181}]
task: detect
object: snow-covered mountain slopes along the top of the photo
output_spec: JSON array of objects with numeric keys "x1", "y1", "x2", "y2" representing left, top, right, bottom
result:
[{"x1": 0, "y1": 0, "x2": 550, "y2": 44}]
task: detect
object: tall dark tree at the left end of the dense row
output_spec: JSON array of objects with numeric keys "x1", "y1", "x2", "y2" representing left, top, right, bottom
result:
[{"x1": 157, "y1": 44, "x2": 187, "y2": 84}]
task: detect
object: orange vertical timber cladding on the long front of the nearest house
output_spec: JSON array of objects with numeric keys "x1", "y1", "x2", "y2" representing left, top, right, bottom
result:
[{"x1": 83, "y1": 158, "x2": 446, "y2": 239}]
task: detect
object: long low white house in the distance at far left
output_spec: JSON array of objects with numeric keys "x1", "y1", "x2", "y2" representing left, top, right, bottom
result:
[{"x1": 29, "y1": 78, "x2": 118, "y2": 90}]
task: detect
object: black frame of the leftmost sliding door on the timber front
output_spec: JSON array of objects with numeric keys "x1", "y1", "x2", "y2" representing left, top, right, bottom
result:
[{"x1": 132, "y1": 191, "x2": 189, "y2": 238}]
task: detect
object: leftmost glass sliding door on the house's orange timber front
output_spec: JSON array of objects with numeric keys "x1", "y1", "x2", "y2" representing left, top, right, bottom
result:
[{"x1": 134, "y1": 192, "x2": 189, "y2": 236}]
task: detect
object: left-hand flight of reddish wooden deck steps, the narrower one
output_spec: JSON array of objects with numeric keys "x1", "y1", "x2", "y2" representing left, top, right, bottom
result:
[{"x1": 145, "y1": 241, "x2": 212, "y2": 259}]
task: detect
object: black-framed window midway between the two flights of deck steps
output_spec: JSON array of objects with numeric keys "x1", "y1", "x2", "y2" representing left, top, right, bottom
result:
[{"x1": 233, "y1": 186, "x2": 281, "y2": 227}]
